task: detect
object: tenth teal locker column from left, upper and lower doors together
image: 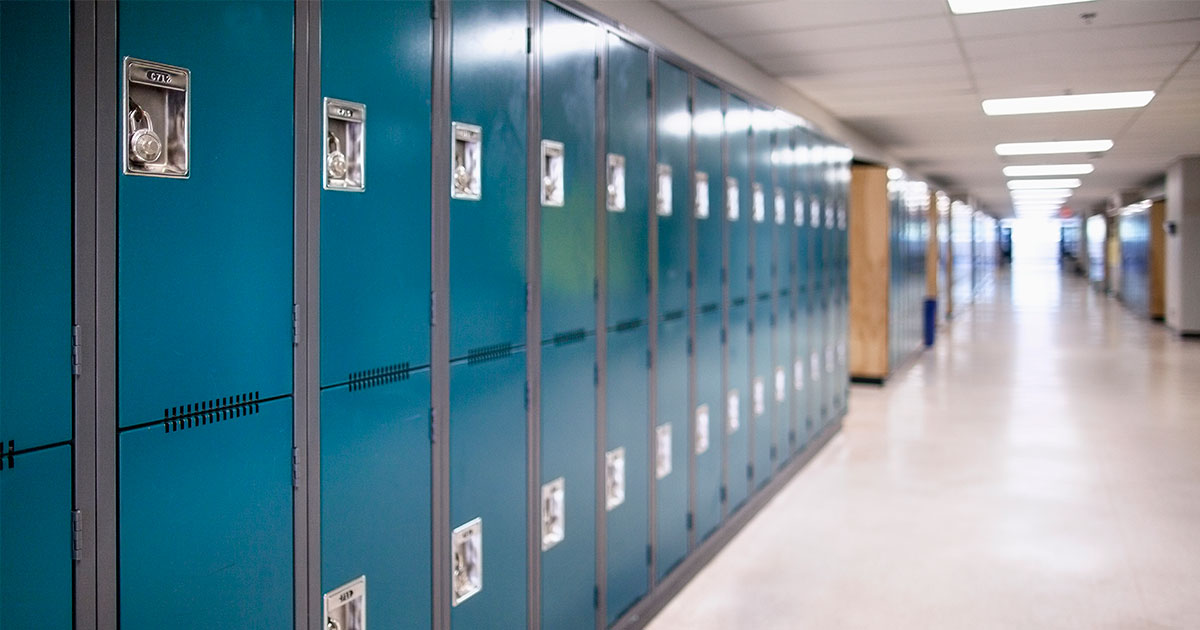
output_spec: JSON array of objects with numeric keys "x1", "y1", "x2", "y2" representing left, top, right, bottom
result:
[{"x1": 750, "y1": 108, "x2": 775, "y2": 486}]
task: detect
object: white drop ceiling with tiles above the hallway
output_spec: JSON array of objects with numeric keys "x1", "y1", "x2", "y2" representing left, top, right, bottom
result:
[{"x1": 656, "y1": 0, "x2": 1200, "y2": 216}]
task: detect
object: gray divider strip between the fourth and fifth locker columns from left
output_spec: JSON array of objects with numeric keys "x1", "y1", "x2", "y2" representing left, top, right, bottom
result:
[{"x1": 526, "y1": 0, "x2": 541, "y2": 630}]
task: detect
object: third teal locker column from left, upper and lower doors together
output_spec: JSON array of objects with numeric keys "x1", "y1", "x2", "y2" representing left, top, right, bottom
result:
[{"x1": 313, "y1": 2, "x2": 432, "y2": 629}]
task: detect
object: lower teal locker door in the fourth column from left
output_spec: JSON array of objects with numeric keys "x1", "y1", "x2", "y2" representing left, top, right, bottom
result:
[{"x1": 446, "y1": 353, "x2": 528, "y2": 630}]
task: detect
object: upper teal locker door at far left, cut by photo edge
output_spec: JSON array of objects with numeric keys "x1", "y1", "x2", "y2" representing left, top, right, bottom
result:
[{"x1": 0, "y1": 1, "x2": 72, "y2": 451}]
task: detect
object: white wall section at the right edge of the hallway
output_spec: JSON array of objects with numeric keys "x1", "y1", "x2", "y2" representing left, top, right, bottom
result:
[{"x1": 1166, "y1": 156, "x2": 1200, "y2": 332}]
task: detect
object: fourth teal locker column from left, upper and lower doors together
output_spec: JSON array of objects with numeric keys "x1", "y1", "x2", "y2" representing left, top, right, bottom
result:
[{"x1": 448, "y1": 1, "x2": 529, "y2": 629}]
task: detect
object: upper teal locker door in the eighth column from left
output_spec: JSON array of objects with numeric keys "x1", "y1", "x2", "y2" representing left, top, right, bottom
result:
[{"x1": 691, "y1": 79, "x2": 725, "y2": 307}]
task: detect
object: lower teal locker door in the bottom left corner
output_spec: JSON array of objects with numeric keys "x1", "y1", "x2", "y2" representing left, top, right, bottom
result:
[{"x1": 0, "y1": 444, "x2": 73, "y2": 630}]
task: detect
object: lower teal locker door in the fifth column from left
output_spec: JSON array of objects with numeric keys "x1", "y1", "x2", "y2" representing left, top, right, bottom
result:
[{"x1": 541, "y1": 337, "x2": 596, "y2": 630}]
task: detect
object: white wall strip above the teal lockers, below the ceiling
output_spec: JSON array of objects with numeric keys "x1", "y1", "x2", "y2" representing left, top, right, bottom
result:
[{"x1": 582, "y1": 0, "x2": 902, "y2": 168}]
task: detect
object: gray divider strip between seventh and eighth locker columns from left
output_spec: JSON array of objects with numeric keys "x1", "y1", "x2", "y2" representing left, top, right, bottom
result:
[{"x1": 684, "y1": 76, "x2": 700, "y2": 553}]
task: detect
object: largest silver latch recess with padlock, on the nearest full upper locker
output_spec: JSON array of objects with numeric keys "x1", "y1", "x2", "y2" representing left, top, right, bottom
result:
[{"x1": 121, "y1": 56, "x2": 191, "y2": 179}]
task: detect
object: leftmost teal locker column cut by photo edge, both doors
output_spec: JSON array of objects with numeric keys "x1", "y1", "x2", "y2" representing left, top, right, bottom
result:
[{"x1": 0, "y1": 1, "x2": 73, "y2": 630}]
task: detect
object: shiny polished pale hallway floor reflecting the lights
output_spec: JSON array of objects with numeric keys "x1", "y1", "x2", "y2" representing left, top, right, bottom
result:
[{"x1": 649, "y1": 266, "x2": 1200, "y2": 630}]
